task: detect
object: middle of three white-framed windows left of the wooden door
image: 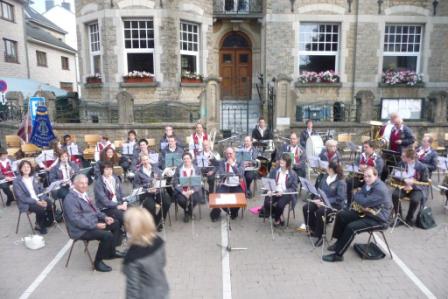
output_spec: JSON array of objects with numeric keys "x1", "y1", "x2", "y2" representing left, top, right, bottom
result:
[{"x1": 123, "y1": 19, "x2": 154, "y2": 74}]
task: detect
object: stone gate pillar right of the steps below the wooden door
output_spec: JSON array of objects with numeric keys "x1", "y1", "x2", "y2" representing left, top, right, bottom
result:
[{"x1": 268, "y1": 74, "x2": 296, "y2": 128}]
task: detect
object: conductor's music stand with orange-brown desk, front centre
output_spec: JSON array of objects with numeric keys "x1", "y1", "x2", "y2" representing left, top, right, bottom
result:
[{"x1": 209, "y1": 193, "x2": 247, "y2": 252}]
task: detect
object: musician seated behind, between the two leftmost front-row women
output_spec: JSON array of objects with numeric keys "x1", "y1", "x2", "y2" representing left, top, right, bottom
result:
[{"x1": 49, "y1": 150, "x2": 79, "y2": 200}]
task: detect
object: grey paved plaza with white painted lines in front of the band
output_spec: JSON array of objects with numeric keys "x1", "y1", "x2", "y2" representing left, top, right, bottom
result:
[{"x1": 0, "y1": 177, "x2": 448, "y2": 299}]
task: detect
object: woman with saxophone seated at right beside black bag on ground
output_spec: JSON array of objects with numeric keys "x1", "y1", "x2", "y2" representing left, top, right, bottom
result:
[{"x1": 392, "y1": 149, "x2": 429, "y2": 226}]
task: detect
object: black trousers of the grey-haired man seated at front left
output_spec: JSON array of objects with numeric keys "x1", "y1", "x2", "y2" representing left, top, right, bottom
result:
[{"x1": 79, "y1": 222, "x2": 121, "y2": 262}]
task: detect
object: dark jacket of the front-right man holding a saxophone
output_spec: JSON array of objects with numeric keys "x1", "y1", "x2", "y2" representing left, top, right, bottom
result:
[{"x1": 353, "y1": 178, "x2": 393, "y2": 222}]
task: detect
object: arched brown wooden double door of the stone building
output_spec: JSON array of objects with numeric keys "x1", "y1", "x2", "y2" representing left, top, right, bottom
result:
[{"x1": 219, "y1": 32, "x2": 252, "y2": 100}]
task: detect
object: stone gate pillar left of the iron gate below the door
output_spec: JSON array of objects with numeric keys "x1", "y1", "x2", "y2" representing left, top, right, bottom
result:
[{"x1": 201, "y1": 75, "x2": 221, "y2": 131}]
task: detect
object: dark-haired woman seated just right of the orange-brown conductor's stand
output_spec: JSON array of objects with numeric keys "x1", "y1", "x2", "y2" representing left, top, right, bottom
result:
[{"x1": 263, "y1": 153, "x2": 297, "y2": 226}]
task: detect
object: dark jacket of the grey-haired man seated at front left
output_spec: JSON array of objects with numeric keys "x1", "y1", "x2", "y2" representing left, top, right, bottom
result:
[{"x1": 62, "y1": 190, "x2": 106, "y2": 239}]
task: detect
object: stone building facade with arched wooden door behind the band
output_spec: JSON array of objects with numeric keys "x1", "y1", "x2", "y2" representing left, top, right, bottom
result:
[{"x1": 76, "y1": 0, "x2": 448, "y2": 134}]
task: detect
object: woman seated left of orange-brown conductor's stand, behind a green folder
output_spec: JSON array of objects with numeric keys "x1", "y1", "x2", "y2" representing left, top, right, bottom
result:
[{"x1": 173, "y1": 153, "x2": 204, "y2": 222}]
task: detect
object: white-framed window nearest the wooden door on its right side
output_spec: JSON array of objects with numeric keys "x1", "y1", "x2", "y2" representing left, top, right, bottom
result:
[{"x1": 299, "y1": 23, "x2": 339, "y2": 73}]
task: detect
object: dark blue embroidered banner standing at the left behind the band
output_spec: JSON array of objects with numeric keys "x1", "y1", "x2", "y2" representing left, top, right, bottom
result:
[{"x1": 30, "y1": 106, "x2": 56, "y2": 147}]
